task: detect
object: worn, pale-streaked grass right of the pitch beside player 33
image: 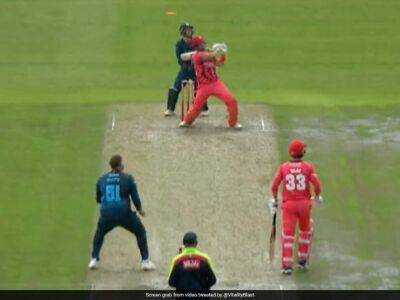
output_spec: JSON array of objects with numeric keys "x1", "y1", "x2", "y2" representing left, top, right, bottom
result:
[{"x1": 274, "y1": 106, "x2": 400, "y2": 288}]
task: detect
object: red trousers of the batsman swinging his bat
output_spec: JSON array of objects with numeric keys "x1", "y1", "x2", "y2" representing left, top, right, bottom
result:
[{"x1": 184, "y1": 80, "x2": 238, "y2": 126}]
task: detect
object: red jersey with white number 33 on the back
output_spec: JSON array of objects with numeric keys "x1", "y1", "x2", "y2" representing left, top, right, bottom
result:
[{"x1": 271, "y1": 161, "x2": 321, "y2": 202}]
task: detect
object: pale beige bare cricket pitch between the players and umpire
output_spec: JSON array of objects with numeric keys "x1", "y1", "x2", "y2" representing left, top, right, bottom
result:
[{"x1": 88, "y1": 103, "x2": 293, "y2": 289}]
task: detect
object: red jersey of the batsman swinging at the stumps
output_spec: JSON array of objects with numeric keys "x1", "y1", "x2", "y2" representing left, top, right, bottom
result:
[{"x1": 192, "y1": 50, "x2": 218, "y2": 85}]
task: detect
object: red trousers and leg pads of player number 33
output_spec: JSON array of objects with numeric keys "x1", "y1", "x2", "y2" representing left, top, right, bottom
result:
[{"x1": 282, "y1": 200, "x2": 313, "y2": 267}]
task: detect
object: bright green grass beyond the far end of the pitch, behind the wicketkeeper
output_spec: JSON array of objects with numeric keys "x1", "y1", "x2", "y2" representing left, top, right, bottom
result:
[{"x1": 0, "y1": 0, "x2": 400, "y2": 106}]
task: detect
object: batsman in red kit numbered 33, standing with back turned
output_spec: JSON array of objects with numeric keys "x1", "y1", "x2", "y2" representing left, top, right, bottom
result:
[{"x1": 270, "y1": 141, "x2": 322, "y2": 275}]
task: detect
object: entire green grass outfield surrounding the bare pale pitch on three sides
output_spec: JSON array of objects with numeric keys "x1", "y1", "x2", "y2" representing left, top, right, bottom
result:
[{"x1": 0, "y1": 0, "x2": 400, "y2": 288}]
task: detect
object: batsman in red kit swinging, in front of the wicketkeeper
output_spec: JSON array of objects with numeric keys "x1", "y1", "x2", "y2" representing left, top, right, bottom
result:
[{"x1": 179, "y1": 36, "x2": 242, "y2": 129}]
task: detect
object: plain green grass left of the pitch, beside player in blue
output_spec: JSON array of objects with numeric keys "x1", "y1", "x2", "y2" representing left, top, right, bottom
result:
[{"x1": 0, "y1": 105, "x2": 105, "y2": 289}]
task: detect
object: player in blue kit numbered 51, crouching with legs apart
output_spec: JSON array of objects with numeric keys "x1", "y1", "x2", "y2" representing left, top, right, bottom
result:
[{"x1": 89, "y1": 155, "x2": 155, "y2": 271}]
